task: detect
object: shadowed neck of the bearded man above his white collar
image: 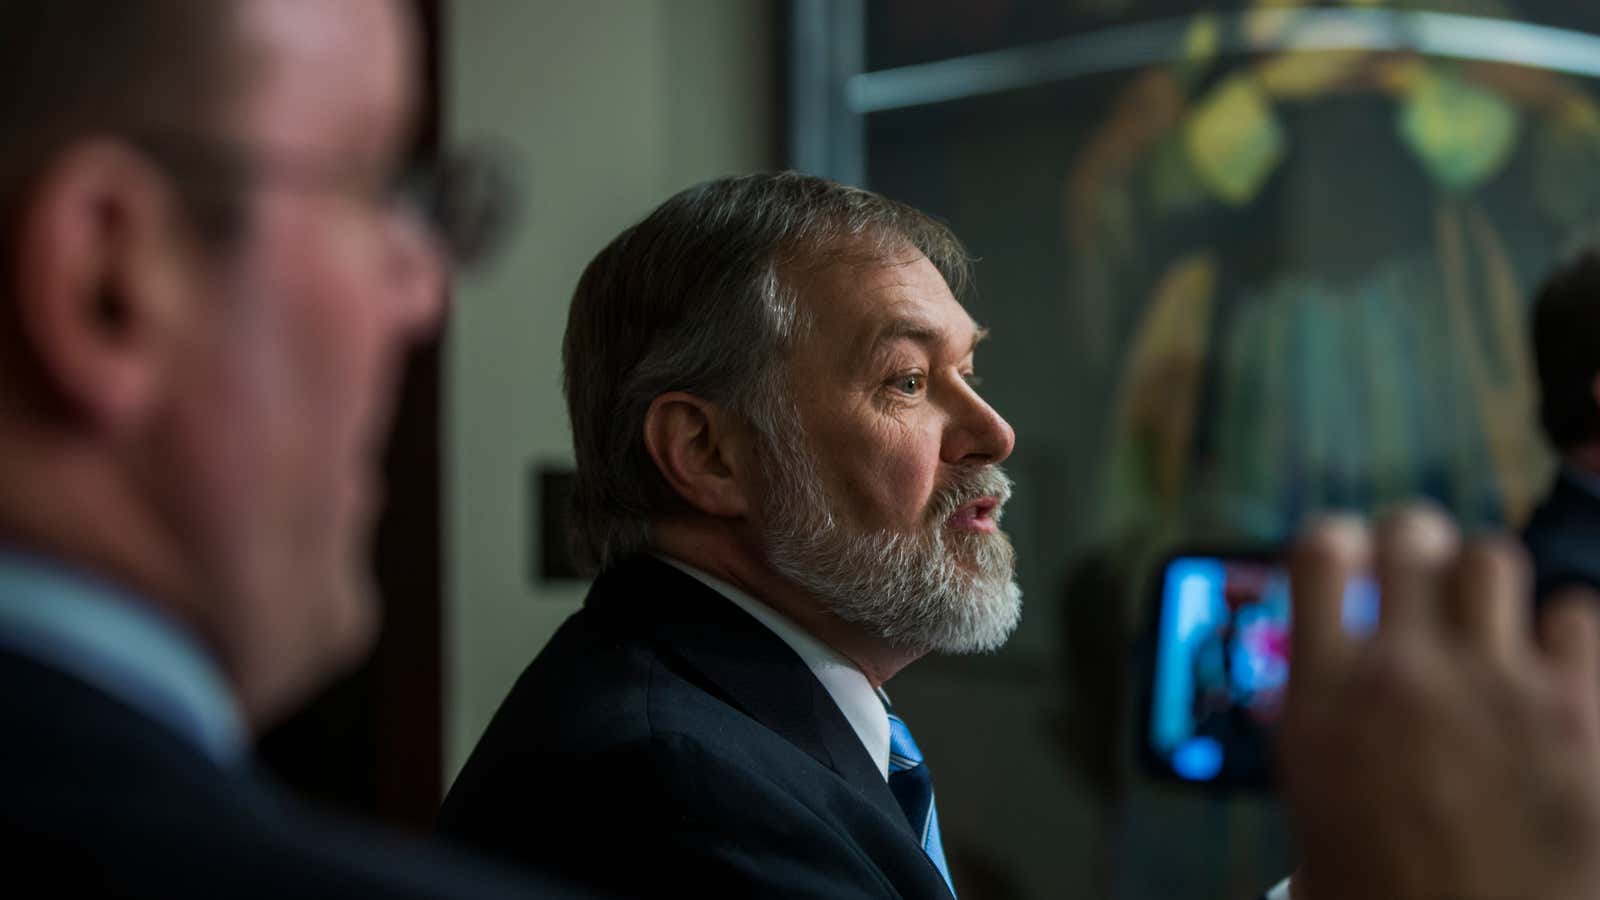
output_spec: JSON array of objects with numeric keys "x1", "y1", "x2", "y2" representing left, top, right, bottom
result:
[{"x1": 651, "y1": 517, "x2": 922, "y2": 687}]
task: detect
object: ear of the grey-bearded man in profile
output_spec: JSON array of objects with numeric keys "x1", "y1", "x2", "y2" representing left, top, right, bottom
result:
[{"x1": 645, "y1": 391, "x2": 752, "y2": 519}]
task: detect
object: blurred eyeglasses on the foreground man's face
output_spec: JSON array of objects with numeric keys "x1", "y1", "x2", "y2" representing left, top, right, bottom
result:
[{"x1": 128, "y1": 133, "x2": 522, "y2": 269}]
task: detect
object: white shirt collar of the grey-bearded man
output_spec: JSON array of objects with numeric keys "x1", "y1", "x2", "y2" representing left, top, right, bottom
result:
[{"x1": 659, "y1": 556, "x2": 890, "y2": 780}]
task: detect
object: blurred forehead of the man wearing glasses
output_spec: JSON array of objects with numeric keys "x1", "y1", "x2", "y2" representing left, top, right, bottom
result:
[{"x1": 238, "y1": 0, "x2": 418, "y2": 154}]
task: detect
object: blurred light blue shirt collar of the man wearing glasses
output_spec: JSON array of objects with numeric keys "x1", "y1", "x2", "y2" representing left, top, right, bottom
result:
[{"x1": 0, "y1": 549, "x2": 246, "y2": 765}]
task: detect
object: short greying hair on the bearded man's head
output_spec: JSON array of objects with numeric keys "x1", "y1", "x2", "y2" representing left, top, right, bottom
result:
[{"x1": 562, "y1": 171, "x2": 970, "y2": 569}]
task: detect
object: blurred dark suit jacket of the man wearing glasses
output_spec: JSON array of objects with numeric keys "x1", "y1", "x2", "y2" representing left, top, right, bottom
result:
[{"x1": 0, "y1": 640, "x2": 579, "y2": 900}]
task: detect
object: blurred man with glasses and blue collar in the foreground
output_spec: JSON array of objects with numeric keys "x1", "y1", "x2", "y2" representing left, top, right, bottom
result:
[{"x1": 0, "y1": 0, "x2": 579, "y2": 898}]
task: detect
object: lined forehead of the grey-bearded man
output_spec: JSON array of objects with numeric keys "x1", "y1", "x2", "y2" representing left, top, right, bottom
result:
[{"x1": 800, "y1": 251, "x2": 979, "y2": 360}]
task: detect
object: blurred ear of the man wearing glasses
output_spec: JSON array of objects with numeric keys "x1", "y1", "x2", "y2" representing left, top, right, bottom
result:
[{"x1": 13, "y1": 139, "x2": 196, "y2": 434}]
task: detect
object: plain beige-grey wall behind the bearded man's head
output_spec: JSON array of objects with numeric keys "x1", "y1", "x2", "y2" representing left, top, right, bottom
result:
[{"x1": 443, "y1": 0, "x2": 776, "y2": 781}]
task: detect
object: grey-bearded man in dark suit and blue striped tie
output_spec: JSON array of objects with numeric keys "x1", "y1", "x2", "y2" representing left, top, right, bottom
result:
[{"x1": 442, "y1": 173, "x2": 1021, "y2": 898}]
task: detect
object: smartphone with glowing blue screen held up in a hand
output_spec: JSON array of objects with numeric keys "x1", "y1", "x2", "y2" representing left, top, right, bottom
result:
[{"x1": 1139, "y1": 548, "x2": 1378, "y2": 788}]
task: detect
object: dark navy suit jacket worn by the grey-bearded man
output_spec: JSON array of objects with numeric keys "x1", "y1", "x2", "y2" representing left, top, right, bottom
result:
[{"x1": 440, "y1": 557, "x2": 949, "y2": 900}]
